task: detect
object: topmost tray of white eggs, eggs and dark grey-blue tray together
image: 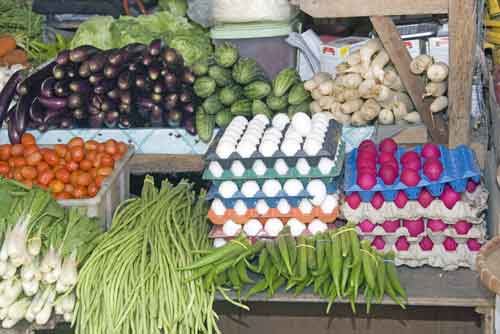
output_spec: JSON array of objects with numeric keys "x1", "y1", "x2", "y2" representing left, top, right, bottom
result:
[{"x1": 205, "y1": 114, "x2": 342, "y2": 169}]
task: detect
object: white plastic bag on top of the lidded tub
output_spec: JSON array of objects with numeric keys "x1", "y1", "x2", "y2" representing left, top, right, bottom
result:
[{"x1": 188, "y1": 0, "x2": 297, "y2": 27}]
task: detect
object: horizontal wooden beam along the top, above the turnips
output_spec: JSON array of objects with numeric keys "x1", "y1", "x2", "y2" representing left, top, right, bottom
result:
[{"x1": 298, "y1": 0, "x2": 448, "y2": 18}]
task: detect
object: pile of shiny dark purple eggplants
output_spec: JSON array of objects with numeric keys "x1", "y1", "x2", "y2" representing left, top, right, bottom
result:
[{"x1": 0, "y1": 39, "x2": 195, "y2": 143}]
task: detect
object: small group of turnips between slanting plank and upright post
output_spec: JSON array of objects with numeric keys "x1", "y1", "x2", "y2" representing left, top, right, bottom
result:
[{"x1": 410, "y1": 55, "x2": 449, "y2": 114}]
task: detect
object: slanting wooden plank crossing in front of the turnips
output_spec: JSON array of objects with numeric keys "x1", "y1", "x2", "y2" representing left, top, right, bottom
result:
[{"x1": 370, "y1": 16, "x2": 448, "y2": 144}]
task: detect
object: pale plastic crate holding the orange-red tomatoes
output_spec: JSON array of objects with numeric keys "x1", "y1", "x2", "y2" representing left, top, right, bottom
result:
[{"x1": 58, "y1": 146, "x2": 134, "y2": 229}]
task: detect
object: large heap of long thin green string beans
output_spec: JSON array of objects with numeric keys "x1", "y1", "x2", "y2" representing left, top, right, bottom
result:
[{"x1": 76, "y1": 176, "x2": 218, "y2": 334}]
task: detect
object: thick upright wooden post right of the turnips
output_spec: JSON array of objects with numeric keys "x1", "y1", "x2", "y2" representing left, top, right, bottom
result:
[{"x1": 448, "y1": 0, "x2": 476, "y2": 147}]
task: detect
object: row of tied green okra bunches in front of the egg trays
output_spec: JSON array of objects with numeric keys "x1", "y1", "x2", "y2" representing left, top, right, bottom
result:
[{"x1": 182, "y1": 224, "x2": 407, "y2": 313}]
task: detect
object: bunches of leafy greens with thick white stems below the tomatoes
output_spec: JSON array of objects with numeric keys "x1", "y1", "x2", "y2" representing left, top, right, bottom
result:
[{"x1": 0, "y1": 178, "x2": 101, "y2": 328}]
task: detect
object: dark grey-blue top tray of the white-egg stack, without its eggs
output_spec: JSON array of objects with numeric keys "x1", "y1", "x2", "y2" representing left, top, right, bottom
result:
[{"x1": 205, "y1": 121, "x2": 342, "y2": 169}]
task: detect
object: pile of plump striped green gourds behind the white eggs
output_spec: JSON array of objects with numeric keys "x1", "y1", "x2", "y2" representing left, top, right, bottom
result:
[{"x1": 192, "y1": 43, "x2": 311, "y2": 142}]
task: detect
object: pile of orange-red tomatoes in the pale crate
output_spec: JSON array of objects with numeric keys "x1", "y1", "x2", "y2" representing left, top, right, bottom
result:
[{"x1": 0, "y1": 133, "x2": 128, "y2": 199}]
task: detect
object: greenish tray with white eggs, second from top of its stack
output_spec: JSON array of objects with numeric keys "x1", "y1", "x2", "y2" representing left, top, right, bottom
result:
[{"x1": 203, "y1": 141, "x2": 345, "y2": 181}]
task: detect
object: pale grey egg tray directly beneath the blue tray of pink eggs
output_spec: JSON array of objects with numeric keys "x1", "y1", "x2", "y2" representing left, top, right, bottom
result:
[{"x1": 341, "y1": 185, "x2": 488, "y2": 224}]
